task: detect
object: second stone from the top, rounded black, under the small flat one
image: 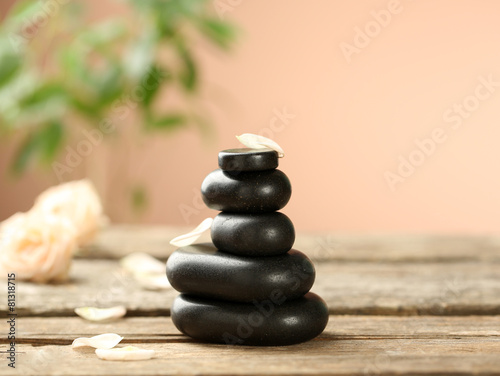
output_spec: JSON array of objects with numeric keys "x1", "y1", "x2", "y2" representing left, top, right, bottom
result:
[{"x1": 201, "y1": 169, "x2": 292, "y2": 213}]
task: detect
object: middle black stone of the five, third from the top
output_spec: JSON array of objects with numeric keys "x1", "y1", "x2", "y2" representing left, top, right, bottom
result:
[{"x1": 211, "y1": 212, "x2": 295, "y2": 256}]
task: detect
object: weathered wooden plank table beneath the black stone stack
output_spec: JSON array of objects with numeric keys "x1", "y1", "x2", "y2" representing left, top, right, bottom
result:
[{"x1": 0, "y1": 226, "x2": 500, "y2": 375}]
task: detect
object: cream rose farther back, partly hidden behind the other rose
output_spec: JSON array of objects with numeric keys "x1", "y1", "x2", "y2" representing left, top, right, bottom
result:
[{"x1": 31, "y1": 179, "x2": 107, "y2": 245}]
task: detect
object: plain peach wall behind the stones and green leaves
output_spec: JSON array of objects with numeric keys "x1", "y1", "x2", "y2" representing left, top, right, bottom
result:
[{"x1": 0, "y1": 0, "x2": 500, "y2": 233}]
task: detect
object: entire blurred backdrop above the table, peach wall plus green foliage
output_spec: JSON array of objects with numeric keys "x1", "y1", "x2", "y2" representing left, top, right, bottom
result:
[{"x1": 0, "y1": 0, "x2": 500, "y2": 234}]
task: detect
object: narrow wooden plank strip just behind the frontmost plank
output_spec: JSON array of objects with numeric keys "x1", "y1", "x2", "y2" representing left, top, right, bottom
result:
[{"x1": 8, "y1": 315, "x2": 500, "y2": 346}]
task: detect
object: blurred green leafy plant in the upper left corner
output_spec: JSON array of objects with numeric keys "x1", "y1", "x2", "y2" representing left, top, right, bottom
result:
[{"x1": 0, "y1": 0, "x2": 234, "y2": 179}]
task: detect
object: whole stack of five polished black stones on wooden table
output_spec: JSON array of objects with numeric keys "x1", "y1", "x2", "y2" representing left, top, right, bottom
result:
[{"x1": 167, "y1": 149, "x2": 328, "y2": 346}]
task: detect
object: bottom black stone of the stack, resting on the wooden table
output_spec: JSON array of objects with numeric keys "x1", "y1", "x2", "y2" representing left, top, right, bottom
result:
[{"x1": 171, "y1": 292, "x2": 328, "y2": 346}]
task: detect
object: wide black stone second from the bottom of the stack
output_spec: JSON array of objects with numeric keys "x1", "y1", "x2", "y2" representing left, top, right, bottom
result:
[{"x1": 167, "y1": 243, "x2": 316, "y2": 302}]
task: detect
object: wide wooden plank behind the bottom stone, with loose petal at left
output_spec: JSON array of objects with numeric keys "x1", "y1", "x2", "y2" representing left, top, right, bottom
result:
[{"x1": 0, "y1": 259, "x2": 500, "y2": 316}]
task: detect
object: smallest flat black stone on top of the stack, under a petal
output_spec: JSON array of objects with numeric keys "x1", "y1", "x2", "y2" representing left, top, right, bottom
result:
[{"x1": 219, "y1": 148, "x2": 278, "y2": 171}]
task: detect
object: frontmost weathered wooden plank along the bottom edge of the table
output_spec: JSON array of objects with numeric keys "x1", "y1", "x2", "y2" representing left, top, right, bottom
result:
[{"x1": 10, "y1": 339, "x2": 500, "y2": 376}]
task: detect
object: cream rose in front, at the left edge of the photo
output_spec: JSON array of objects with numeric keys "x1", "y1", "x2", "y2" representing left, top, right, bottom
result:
[{"x1": 0, "y1": 212, "x2": 77, "y2": 283}]
